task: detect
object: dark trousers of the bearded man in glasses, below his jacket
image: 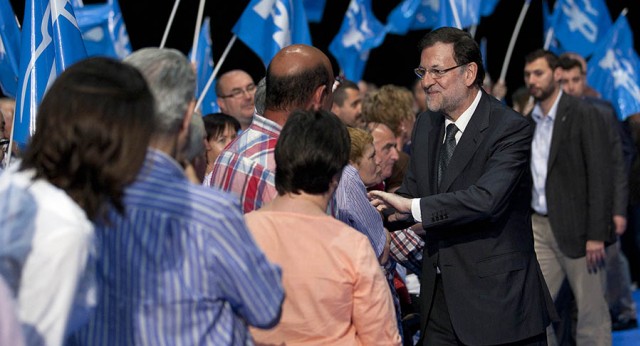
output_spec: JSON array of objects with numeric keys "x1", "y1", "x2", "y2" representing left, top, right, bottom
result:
[{"x1": 423, "y1": 275, "x2": 547, "y2": 346}]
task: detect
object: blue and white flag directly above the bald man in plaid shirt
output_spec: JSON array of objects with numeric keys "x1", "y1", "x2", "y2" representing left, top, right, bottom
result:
[{"x1": 231, "y1": 0, "x2": 311, "y2": 65}]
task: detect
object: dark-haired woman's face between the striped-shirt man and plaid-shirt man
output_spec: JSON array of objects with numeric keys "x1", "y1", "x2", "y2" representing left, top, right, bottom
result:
[{"x1": 202, "y1": 113, "x2": 240, "y2": 186}]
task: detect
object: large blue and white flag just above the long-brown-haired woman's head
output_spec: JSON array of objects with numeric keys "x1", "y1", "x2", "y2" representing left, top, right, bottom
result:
[{"x1": 13, "y1": 0, "x2": 87, "y2": 147}]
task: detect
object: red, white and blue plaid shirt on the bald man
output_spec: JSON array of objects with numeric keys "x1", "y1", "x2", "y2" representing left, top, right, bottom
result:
[{"x1": 211, "y1": 114, "x2": 282, "y2": 213}]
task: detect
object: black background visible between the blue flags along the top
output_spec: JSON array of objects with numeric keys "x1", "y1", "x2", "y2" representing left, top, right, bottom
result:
[{"x1": 6, "y1": 0, "x2": 640, "y2": 104}]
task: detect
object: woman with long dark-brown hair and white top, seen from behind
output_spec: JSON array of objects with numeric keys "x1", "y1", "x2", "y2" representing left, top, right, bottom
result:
[{"x1": 0, "y1": 58, "x2": 154, "y2": 345}]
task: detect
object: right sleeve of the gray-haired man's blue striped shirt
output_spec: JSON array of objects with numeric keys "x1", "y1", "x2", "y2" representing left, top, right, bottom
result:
[{"x1": 209, "y1": 204, "x2": 284, "y2": 328}]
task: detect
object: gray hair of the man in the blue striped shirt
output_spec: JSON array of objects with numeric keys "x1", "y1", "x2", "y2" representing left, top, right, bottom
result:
[{"x1": 124, "y1": 48, "x2": 196, "y2": 134}]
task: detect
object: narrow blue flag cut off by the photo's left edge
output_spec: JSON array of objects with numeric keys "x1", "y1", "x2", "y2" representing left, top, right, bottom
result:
[{"x1": 0, "y1": 0, "x2": 20, "y2": 97}]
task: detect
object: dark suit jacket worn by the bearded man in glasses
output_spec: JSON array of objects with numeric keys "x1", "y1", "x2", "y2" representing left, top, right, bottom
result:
[{"x1": 398, "y1": 92, "x2": 555, "y2": 345}]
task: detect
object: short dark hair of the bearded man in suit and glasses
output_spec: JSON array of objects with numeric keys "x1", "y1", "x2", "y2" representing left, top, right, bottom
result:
[{"x1": 418, "y1": 27, "x2": 485, "y2": 87}]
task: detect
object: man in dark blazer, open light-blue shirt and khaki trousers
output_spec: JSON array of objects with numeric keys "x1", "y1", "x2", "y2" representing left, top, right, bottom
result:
[{"x1": 524, "y1": 50, "x2": 615, "y2": 345}]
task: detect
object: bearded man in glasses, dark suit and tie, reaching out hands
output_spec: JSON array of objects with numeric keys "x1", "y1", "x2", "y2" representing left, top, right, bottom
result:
[{"x1": 370, "y1": 28, "x2": 554, "y2": 345}]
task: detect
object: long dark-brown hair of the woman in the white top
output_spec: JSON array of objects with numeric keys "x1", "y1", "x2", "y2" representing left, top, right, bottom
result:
[{"x1": 21, "y1": 58, "x2": 154, "y2": 219}]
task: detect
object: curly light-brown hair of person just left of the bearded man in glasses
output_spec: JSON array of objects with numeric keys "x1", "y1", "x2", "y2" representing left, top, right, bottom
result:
[{"x1": 362, "y1": 84, "x2": 414, "y2": 136}]
